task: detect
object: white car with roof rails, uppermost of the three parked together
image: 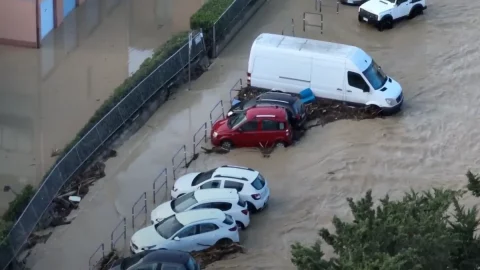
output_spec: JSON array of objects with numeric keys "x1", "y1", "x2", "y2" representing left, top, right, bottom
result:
[{"x1": 171, "y1": 165, "x2": 270, "y2": 212}]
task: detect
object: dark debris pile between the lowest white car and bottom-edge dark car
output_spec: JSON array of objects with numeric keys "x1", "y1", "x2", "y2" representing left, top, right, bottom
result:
[{"x1": 191, "y1": 243, "x2": 245, "y2": 269}]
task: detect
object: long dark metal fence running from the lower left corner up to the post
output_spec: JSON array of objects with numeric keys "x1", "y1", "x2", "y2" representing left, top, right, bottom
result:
[{"x1": 0, "y1": 32, "x2": 205, "y2": 269}]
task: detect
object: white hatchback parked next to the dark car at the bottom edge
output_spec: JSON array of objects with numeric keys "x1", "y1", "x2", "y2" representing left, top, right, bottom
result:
[{"x1": 130, "y1": 209, "x2": 240, "y2": 254}]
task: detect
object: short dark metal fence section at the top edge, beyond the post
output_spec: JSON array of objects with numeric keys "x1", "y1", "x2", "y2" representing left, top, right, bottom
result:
[{"x1": 211, "y1": 0, "x2": 257, "y2": 57}]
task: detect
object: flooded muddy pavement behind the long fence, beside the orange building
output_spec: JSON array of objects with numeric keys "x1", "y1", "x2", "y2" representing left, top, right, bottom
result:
[{"x1": 0, "y1": 0, "x2": 205, "y2": 212}]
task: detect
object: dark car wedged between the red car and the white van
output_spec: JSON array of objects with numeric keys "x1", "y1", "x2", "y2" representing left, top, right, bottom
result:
[{"x1": 227, "y1": 91, "x2": 307, "y2": 128}]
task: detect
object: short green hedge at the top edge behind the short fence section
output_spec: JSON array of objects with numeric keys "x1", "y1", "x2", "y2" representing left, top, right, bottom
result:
[{"x1": 190, "y1": 0, "x2": 234, "y2": 47}]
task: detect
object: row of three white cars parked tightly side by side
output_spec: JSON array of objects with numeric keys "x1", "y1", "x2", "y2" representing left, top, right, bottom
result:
[{"x1": 130, "y1": 165, "x2": 270, "y2": 254}]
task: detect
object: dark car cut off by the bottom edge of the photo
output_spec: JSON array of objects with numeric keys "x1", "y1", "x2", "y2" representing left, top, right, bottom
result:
[{"x1": 110, "y1": 250, "x2": 200, "y2": 270}]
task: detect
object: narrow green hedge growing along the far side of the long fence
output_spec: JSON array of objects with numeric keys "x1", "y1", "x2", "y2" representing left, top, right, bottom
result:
[{"x1": 0, "y1": 32, "x2": 188, "y2": 245}]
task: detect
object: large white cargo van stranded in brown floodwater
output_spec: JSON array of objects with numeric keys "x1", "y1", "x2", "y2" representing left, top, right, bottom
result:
[{"x1": 247, "y1": 33, "x2": 403, "y2": 114}]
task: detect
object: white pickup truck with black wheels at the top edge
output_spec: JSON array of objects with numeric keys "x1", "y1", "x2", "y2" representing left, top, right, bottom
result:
[{"x1": 358, "y1": 0, "x2": 427, "y2": 31}]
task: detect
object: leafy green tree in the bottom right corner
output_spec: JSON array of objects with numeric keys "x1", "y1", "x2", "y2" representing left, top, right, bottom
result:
[{"x1": 292, "y1": 172, "x2": 480, "y2": 270}]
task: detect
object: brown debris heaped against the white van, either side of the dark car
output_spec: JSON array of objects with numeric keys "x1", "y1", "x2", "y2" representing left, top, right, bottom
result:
[{"x1": 237, "y1": 87, "x2": 381, "y2": 128}]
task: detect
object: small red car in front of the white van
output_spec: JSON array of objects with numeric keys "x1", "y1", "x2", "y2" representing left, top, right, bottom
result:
[{"x1": 211, "y1": 106, "x2": 293, "y2": 149}]
